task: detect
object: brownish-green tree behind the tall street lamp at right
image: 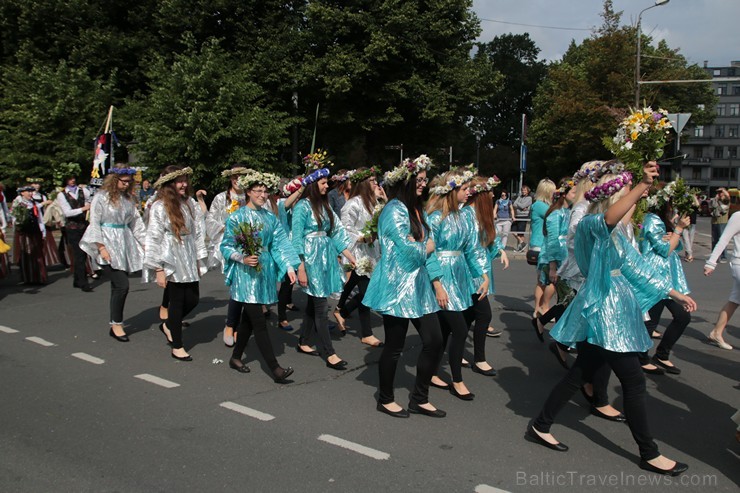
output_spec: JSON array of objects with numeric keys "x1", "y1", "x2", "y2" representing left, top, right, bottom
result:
[{"x1": 529, "y1": 0, "x2": 715, "y2": 178}]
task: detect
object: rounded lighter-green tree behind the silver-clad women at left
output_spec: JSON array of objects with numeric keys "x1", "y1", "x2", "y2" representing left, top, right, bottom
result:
[{"x1": 122, "y1": 38, "x2": 292, "y2": 185}]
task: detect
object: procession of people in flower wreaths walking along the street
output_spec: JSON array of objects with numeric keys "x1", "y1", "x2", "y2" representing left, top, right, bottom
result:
[{"x1": 0, "y1": 152, "x2": 740, "y2": 475}]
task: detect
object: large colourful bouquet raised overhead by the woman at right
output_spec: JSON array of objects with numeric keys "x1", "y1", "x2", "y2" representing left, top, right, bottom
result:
[{"x1": 603, "y1": 106, "x2": 673, "y2": 181}]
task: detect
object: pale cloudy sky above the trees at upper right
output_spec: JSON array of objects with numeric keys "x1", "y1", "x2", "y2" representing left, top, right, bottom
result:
[{"x1": 473, "y1": 0, "x2": 740, "y2": 67}]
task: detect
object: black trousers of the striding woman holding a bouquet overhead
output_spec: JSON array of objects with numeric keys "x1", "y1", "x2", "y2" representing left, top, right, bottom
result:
[{"x1": 533, "y1": 342, "x2": 660, "y2": 460}]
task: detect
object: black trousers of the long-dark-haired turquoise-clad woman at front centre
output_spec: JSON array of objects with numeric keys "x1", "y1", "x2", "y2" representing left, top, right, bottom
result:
[{"x1": 378, "y1": 313, "x2": 442, "y2": 404}]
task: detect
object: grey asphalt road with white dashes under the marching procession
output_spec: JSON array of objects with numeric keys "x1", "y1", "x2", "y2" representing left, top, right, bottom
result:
[{"x1": 0, "y1": 218, "x2": 740, "y2": 492}]
